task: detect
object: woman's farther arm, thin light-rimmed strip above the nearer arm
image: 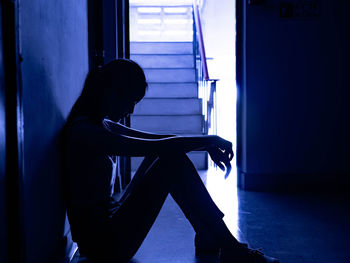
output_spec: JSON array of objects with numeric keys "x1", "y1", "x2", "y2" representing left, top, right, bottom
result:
[{"x1": 103, "y1": 119, "x2": 176, "y2": 139}]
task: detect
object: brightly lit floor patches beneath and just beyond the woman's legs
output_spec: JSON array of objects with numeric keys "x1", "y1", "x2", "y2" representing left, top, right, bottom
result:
[{"x1": 132, "y1": 167, "x2": 244, "y2": 263}]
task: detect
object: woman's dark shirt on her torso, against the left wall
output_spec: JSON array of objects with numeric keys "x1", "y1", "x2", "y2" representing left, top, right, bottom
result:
[{"x1": 65, "y1": 117, "x2": 119, "y2": 207}]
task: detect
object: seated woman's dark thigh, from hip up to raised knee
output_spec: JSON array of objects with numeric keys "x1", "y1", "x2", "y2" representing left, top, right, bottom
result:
[{"x1": 108, "y1": 158, "x2": 172, "y2": 263}]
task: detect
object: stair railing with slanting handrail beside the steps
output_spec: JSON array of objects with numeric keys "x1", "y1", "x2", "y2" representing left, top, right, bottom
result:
[{"x1": 193, "y1": 0, "x2": 218, "y2": 134}]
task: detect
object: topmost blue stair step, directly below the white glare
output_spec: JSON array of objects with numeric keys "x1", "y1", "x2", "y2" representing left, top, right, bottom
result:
[{"x1": 130, "y1": 42, "x2": 193, "y2": 54}]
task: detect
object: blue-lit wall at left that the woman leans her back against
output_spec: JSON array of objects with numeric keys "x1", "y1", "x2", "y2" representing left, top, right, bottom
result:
[{"x1": 19, "y1": 0, "x2": 88, "y2": 263}]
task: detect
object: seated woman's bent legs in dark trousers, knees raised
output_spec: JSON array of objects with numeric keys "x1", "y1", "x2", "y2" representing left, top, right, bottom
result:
[{"x1": 109, "y1": 154, "x2": 235, "y2": 262}]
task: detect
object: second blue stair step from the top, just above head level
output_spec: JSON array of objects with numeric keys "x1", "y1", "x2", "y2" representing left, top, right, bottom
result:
[{"x1": 131, "y1": 55, "x2": 194, "y2": 68}]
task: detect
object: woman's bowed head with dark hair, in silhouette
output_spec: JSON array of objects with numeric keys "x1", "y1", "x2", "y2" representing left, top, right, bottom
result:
[{"x1": 72, "y1": 59, "x2": 147, "y2": 121}]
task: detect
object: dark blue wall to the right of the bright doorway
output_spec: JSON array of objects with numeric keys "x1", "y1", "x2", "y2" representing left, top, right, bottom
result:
[{"x1": 239, "y1": 0, "x2": 350, "y2": 189}]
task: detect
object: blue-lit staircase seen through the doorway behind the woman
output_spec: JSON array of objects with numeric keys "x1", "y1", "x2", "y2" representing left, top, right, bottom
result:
[{"x1": 130, "y1": 3, "x2": 207, "y2": 171}]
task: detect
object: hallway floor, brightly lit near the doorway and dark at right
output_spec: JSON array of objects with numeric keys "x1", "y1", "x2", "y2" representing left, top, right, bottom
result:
[{"x1": 133, "y1": 171, "x2": 350, "y2": 263}]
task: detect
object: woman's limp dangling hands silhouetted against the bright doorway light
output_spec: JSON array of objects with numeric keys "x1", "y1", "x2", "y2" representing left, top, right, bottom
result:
[{"x1": 207, "y1": 136, "x2": 234, "y2": 178}]
